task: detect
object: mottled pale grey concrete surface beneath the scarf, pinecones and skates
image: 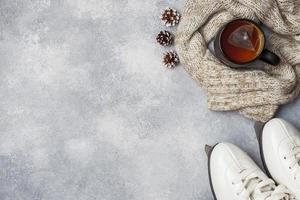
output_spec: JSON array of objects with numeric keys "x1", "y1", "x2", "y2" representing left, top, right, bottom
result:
[{"x1": 0, "y1": 0, "x2": 300, "y2": 200}]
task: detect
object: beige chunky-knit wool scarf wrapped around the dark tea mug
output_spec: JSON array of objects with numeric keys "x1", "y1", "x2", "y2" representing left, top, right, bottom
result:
[{"x1": 175, "y1": 0, "x2": 300, "y2": 122}]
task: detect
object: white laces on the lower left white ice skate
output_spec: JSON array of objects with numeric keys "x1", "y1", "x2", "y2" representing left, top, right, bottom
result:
[{"x1": 232, "y1": 169, "x2": 295, "y2": 200}]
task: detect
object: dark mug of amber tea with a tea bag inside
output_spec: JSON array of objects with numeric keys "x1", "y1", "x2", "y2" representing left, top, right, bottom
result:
[{"x1": 214, "y1": 19, "x2": 280, "y2": 68}]
